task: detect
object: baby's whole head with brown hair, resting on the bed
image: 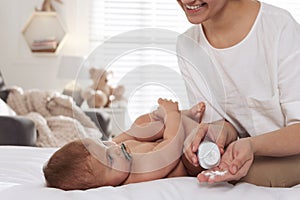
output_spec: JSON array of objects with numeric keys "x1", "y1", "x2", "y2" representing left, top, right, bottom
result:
[{"x1": 43, "y1": 139, "x2": 131, "y2": 190}]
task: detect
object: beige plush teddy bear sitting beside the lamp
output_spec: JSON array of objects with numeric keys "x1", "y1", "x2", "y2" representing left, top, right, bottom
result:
[{"x1": 82, "y1": 67, "x2": 125, "y2": 108}]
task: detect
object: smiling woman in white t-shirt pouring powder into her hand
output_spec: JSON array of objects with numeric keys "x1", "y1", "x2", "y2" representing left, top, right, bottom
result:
[{"x1": 177, "y1": 0, "x2": 300, "y2": 187}]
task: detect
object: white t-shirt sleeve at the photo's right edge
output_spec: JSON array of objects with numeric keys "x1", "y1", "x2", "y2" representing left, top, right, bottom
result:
[{"x1": 278, "y1": 16, "x2": 300, "y2": 125}]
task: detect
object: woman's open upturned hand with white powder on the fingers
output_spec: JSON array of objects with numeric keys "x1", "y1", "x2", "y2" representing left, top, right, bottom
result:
[{"x1": 197, "y1": 138, "x2": 254, "y2": 183}]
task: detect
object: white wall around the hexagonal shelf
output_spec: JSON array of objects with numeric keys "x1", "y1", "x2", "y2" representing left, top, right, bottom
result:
[{"x1": 0, "y1": 0, "x2": 89, "y2": 90}]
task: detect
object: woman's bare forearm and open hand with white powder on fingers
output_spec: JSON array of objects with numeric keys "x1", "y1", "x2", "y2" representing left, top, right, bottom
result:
[{"x1": 198, "y1": 123, "x2": 300, "y2": 182}]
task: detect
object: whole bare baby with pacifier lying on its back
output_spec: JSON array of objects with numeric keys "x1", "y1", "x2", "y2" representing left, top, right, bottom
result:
[{"x1": 43, "y1": 99, "x2": 205, "y2": 190}]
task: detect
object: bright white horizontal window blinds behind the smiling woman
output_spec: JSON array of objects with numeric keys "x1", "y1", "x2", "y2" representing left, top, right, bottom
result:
[{"x1": 89, "y1": 0, "x2": 300, "y2": 123}]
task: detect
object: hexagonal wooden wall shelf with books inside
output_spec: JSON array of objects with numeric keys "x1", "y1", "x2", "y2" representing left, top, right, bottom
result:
[{"x1": 22, "y1": 12, "x2": 67, "y2": 54}]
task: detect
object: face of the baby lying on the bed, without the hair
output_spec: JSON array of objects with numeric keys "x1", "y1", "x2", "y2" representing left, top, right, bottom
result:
[{"x1": 87, "y1": 140, "x2": 131, "y2": 186}]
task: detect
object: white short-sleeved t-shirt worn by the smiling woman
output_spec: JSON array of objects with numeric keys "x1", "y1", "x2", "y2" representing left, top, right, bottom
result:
[{"x1": 177, "y1": 3, "x2": 300, "y2": 136}]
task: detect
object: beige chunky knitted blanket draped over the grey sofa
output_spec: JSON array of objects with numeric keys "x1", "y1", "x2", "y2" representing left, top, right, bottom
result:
[{"x1": 7, "y1": 88, "x2": 102, "y2": 147}]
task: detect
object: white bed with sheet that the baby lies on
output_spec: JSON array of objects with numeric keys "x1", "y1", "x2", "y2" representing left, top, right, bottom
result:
[{"x1": 0, "y1": 146, "x2": 300, "y2": 200}]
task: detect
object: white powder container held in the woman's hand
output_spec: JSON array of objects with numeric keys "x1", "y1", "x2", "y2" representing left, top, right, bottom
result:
[{"x1": 198, "y1": 136, "x2": 221, "y2": 169}]
